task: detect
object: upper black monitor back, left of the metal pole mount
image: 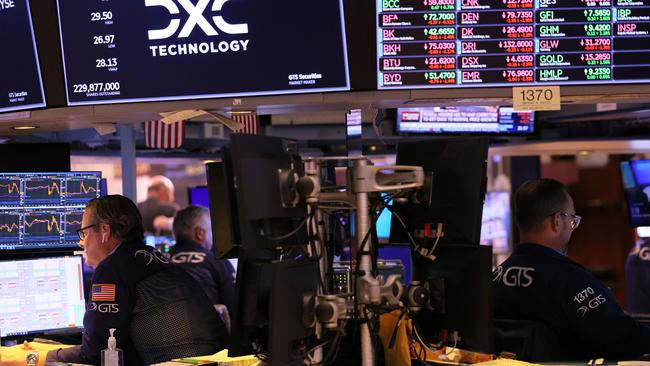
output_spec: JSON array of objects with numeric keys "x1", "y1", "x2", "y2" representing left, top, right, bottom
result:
[{"x1": 224, "y1": 134, "x2": 307, "y2": 253}]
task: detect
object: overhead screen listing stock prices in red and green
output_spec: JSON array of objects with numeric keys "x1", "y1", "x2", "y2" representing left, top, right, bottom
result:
[{"x1": 377, "y1": 0, "x2": 650, "y2": 89}]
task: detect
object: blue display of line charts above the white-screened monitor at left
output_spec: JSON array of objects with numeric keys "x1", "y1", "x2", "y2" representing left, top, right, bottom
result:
[{"x1": 0, "y1": 172, "x2": 101, "y2": 251}]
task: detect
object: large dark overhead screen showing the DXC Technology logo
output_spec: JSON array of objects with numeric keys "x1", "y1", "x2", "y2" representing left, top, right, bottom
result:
[{"x1": 58, "y1": 0, "x2": 349, "y2": 105}]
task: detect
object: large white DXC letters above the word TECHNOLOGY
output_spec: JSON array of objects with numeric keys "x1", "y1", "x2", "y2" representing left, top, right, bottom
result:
[{"x1": 144, "y1": 0, "x2": 248, "y2": 40}]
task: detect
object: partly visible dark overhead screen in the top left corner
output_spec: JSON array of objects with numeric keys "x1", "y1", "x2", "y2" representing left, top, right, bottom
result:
[{"x1": 0, "y1": 0, "x2": 45, "y2": 113}]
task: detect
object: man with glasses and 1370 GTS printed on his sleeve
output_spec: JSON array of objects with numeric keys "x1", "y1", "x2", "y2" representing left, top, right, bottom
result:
[{"x1": 493, "y1": 179, "x2": 650, "y2": 361}]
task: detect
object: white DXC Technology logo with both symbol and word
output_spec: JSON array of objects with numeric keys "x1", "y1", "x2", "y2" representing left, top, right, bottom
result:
[{"x1": 144, "y1": 0, "x2": 250, "y2": 57}]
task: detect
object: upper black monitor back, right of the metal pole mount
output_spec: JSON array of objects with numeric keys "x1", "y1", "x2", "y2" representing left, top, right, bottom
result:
[{"x1": 390, "y1": 138, "x2": 488, "y2": 246}]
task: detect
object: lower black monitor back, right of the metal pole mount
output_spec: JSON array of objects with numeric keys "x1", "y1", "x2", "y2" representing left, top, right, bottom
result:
[{"x1": 413, "y1": 245, "x2": 494, "y2": 353}]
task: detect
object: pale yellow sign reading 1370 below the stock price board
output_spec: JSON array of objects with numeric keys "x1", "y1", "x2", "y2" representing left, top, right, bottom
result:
[{"x1": 512, "y1": 86, "x2": 562, "y2": 111}]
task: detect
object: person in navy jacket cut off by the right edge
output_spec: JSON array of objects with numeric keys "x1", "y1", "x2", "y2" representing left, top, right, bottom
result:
[{"x1": 625, "y1": 240, "x2": 650, "y2": 314}]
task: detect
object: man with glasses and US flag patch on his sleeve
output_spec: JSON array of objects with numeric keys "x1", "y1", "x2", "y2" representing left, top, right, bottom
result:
[{"x1": 47, "y1": 195, "x2": 227, "y2": 365}]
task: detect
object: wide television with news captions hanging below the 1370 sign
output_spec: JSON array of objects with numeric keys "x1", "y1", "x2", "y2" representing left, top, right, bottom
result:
[{"x1": 397, "y1": 106, "x2": 535, "y2": 134}]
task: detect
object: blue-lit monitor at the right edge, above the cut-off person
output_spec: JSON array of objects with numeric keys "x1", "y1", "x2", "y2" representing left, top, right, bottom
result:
[{"x1": 621, "y1": 160, "x2": 650, "y2": 227}]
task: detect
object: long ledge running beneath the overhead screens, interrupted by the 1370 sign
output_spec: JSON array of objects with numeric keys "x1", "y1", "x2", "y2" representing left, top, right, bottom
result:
[{"x1": 0, "y1": 85, "x2": 650, "y2": 136}]
